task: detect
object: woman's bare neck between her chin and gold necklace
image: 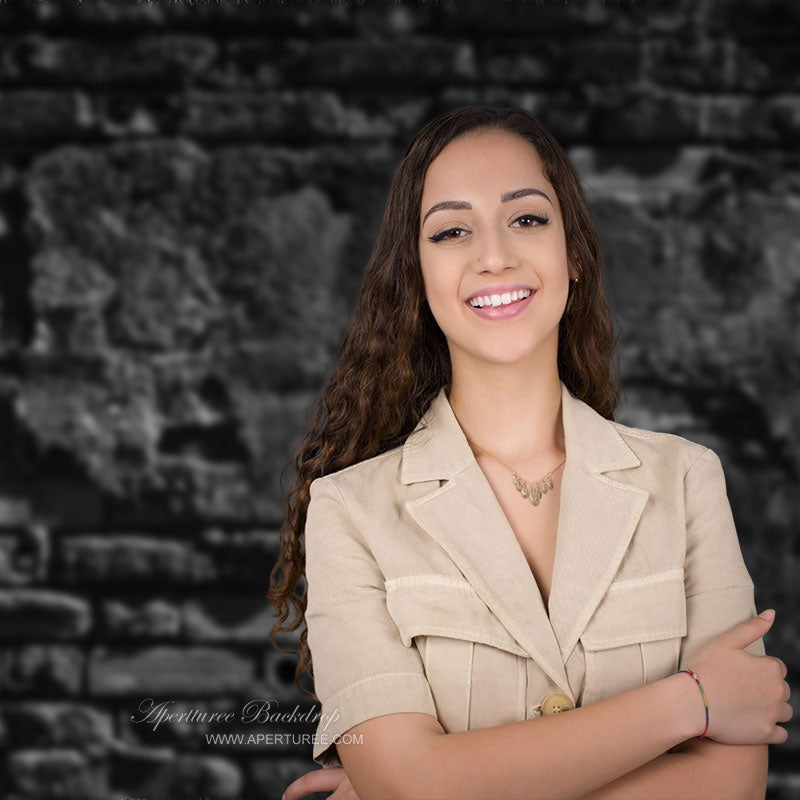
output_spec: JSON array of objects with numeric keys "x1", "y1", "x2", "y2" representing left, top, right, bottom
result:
[{"x1": 448, "y1": 370, "x2": 565, "y2": 474}]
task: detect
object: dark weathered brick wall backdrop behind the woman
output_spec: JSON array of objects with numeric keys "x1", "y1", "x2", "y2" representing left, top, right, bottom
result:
[{"x1": 0, "y1": 0, "x2": 800, "y2": 800}]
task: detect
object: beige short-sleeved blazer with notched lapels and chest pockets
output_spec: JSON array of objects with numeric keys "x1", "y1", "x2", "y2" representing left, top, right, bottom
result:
[{"x1": 305, "y1": 382, "x2": 765, "y2": 765}]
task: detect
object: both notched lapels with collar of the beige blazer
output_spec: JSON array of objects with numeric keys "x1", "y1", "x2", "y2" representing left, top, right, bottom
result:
[{"x1": 401, "y1": 381, "x2": 649, "y2": 696}]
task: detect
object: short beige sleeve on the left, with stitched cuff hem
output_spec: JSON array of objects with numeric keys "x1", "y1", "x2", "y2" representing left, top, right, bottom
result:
[{"x1": 305, "y1": 476, "x2": 436, "y2": 766}]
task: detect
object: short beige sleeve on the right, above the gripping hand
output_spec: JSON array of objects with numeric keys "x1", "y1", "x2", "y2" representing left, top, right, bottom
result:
[{"x1": 679, "y1": 448, "x2": 765, "y2": 669}]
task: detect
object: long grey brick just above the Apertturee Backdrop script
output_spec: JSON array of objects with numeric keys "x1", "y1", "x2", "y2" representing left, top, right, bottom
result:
[{"x1": 89, "y1": 646, "x2": 253, "y2": 699}]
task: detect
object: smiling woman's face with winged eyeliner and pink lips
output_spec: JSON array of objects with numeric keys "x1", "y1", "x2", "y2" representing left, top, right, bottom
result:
[{"x1": 419, "y1": 131, "x2": 574, "y2": 363}]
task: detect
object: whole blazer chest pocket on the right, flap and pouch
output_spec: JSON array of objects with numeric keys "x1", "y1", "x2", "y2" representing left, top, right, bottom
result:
[{"x1": 581, "y1": 567, "x2": 686, "y2": 705}]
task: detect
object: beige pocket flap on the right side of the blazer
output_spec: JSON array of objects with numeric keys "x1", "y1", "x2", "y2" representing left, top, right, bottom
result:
[{"x1": 581, "y1": 567, "x2": 686, "y2": 650}]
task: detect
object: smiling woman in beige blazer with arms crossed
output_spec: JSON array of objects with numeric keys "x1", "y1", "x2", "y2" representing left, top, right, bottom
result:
[{"x1": 270, "y1": 107, "x2": 792, "y2": 800}]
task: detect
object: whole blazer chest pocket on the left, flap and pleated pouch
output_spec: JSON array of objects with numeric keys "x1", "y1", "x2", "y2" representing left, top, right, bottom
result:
[{"x1": 386, "y1": 575, "x2": 528, "y2": 733}]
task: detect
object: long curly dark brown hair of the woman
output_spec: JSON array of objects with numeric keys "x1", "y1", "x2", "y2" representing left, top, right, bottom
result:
[{"x1": 267, "y1": 106, "x2": 619, "y2": 699}]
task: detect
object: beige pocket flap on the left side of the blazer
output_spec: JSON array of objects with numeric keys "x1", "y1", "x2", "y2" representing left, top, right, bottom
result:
[{"x1": 386, "y1": 575, "x2": 527, "y2": 656}]
